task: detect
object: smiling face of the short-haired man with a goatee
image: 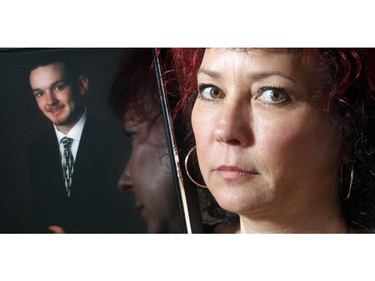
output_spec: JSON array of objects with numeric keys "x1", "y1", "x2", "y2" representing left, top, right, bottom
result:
[{"x1": 29, "y1": 62, "x2": 88, "y2": 133}]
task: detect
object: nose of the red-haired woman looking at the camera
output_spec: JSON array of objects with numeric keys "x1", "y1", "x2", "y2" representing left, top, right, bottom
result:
[{"x1": 214, "y1": 101, "x2": 252, "y2": 146}]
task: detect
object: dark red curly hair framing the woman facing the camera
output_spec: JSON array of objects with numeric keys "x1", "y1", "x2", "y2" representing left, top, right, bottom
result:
[{"x1": 166, "y1": 48, "x2": 375, "y2": 229}]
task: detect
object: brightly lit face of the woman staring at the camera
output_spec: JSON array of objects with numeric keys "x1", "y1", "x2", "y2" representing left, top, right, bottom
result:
[{"x1": 192, "y1": 49, "x2": 340, "y2": 217}]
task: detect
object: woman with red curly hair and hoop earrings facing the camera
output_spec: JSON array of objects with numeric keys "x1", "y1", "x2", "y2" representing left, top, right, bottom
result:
[{"x1": 171, "y1": 48, "x2": 375, "y2": 233}]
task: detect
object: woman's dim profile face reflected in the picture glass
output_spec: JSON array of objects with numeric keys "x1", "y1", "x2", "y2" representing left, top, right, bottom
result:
[{"x1": 119, "y1": 107, "x2": 181, "y2": 233}]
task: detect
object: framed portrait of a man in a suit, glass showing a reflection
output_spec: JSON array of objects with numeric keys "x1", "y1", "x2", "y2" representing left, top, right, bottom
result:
[{"x1": 0, "y1": 48, "x2": 204, "y2": 233}]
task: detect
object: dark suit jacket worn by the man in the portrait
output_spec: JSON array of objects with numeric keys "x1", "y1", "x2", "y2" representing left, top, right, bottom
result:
[{"x1": 28, "y1": 115, "x2": 146, "y2": 233}]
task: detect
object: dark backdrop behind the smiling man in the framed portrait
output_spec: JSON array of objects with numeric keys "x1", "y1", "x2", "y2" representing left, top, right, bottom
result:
[{"x1": 0, "y1": 48, "x2": 141, "y2": 233}]
